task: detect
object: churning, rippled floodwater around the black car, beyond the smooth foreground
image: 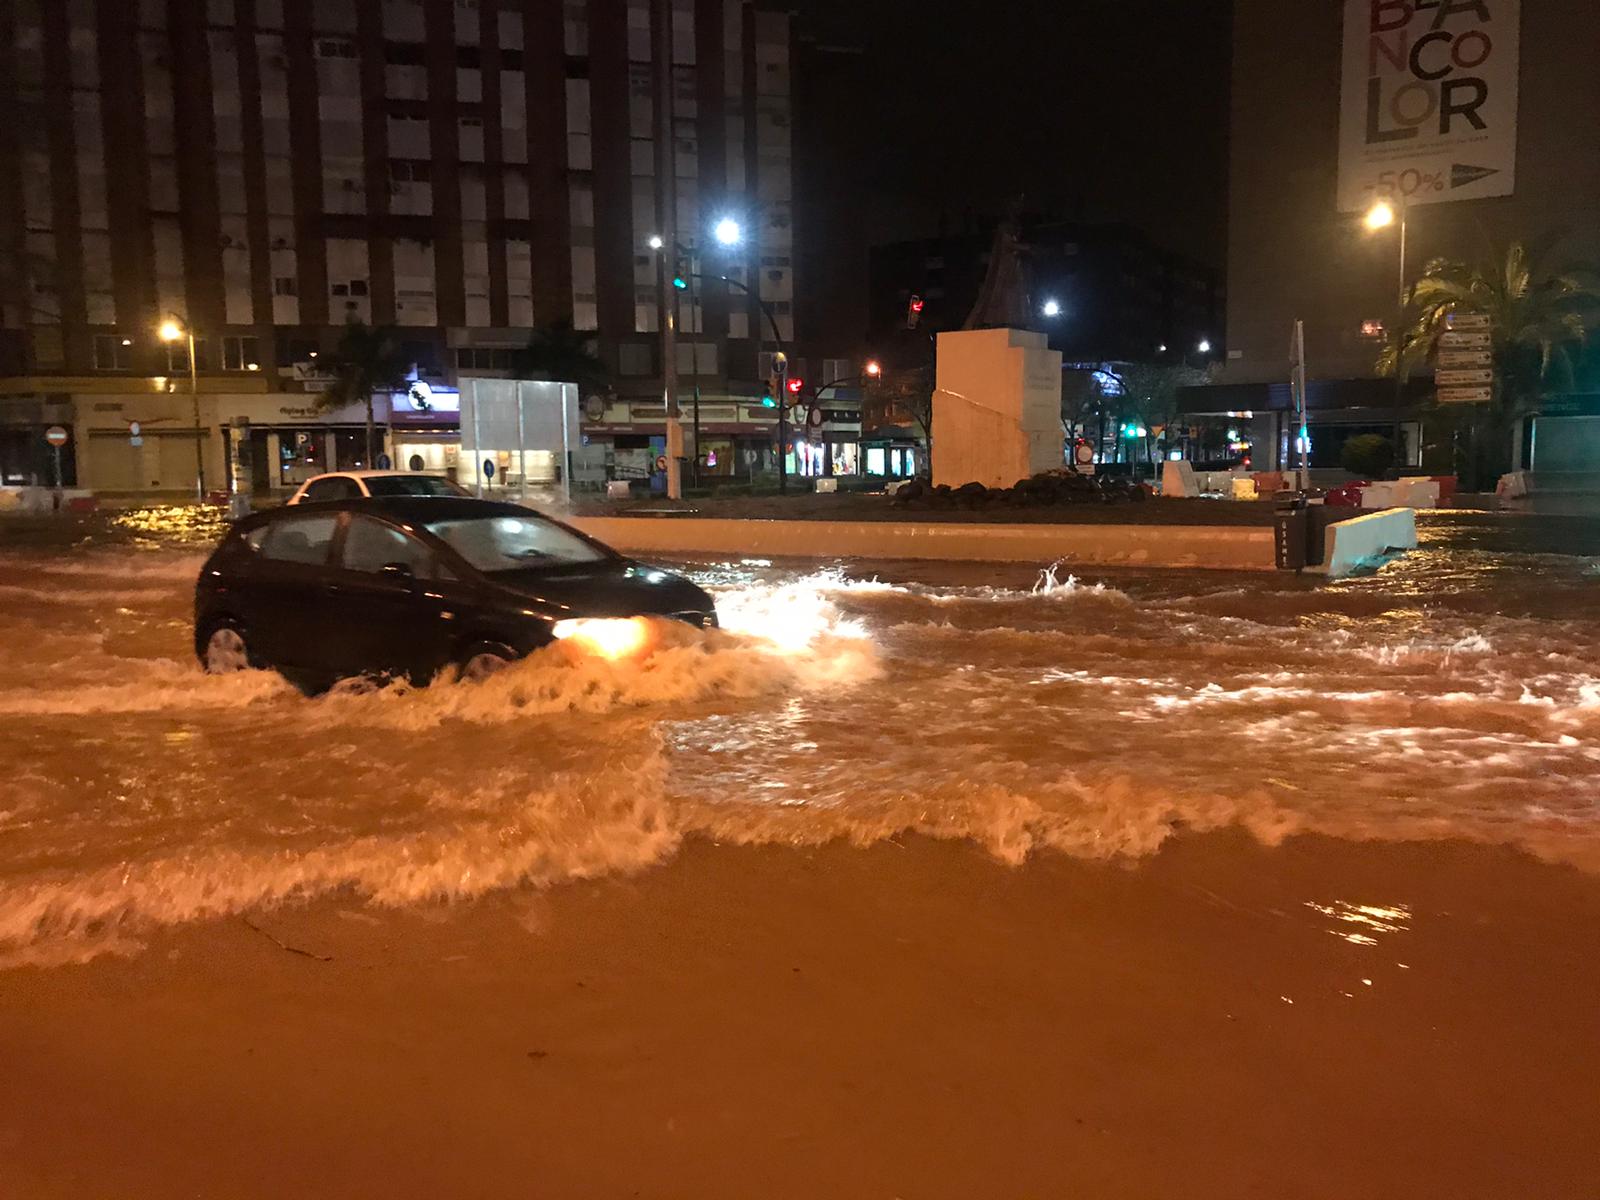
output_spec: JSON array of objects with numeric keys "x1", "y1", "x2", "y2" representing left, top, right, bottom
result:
[{"x1": 0, "y1": 514, "x2": 1600, "y2": 963}]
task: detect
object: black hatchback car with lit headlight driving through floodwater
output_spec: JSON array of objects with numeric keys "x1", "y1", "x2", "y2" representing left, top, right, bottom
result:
[{"x1": 195, "y1": 496, "x2": 717, "y2": 688}]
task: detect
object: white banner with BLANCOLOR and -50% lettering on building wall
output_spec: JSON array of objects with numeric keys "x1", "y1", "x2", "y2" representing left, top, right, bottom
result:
[{"x1": 1339, "y1": 0, "x2": 1522, "y2": 213}]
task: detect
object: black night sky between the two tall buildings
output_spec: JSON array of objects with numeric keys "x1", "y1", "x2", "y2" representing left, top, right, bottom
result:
[{"x1": 795, "y1": 0, "x2": 1229, "y2": 267}]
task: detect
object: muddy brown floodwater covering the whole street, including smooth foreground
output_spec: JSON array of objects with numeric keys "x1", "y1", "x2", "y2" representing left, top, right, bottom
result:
[{"x1": 0, "y1": 514, "x2": 1600, "y2": 1198}]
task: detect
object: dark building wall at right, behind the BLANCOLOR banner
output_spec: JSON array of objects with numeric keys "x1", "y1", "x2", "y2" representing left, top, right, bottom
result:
[{"x1": 1190, "y1": 0, "x2": 1600, "y2": 472}]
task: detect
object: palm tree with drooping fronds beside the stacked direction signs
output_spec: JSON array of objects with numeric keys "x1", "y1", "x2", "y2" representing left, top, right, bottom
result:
[{"x1": 1378, "y1": 242, "x2": 1600, "y2": 486}]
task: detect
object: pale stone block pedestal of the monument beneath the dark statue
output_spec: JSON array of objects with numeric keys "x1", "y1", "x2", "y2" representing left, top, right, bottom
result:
[{"x1": 933, "y1": 330, "x2": 1066, "y2": 488}]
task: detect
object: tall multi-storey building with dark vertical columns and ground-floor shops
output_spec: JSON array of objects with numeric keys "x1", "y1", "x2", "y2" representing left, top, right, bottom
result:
[{"x1": 0, "y1": 0, "x2": 819, "y2": 493}]
